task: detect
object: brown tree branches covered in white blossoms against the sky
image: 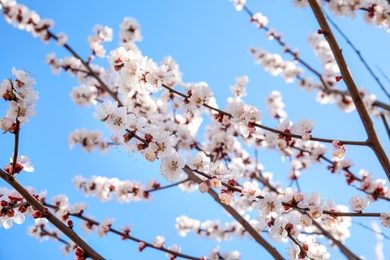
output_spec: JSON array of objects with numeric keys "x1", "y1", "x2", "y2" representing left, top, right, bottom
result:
[{"x1": 0, "y1": 0, "x2": 390, "y2": 260}]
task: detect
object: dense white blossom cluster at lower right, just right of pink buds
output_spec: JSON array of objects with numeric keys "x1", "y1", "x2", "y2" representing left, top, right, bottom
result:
[{"x1": 253, "y1": 188, "x2": 351, "y2": 253}]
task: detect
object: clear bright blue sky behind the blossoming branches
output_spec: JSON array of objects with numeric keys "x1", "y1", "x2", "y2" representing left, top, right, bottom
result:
[{"x1": 0, "y1": 0, "x2": 390, "y2": 259}]
